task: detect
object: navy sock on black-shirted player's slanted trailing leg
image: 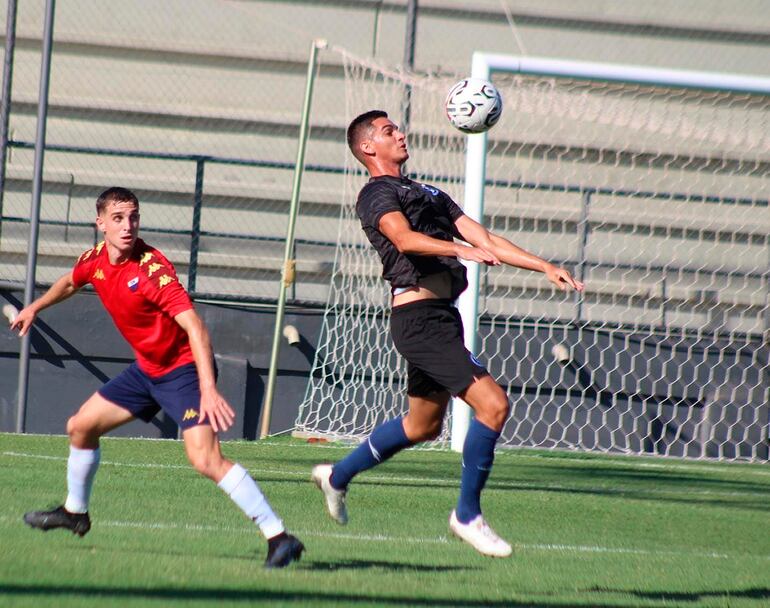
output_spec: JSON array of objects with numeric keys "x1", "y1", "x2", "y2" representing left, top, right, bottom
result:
[{"x1": 329, "y1": 417, "x2": 412, "y2": 490}]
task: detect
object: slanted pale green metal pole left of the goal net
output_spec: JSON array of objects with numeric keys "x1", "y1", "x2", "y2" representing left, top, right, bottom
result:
[{"x1": 259, "y1": 40, "x2": 326, "y2": 439}]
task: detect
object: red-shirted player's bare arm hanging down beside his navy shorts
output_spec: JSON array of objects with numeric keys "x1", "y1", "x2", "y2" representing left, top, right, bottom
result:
[{"x1": 174, "y1": 309, "x2": 235, "y2": 432}]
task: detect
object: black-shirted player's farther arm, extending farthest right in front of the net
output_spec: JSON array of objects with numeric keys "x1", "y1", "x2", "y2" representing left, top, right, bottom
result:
[{"x1": 455, "y1": 215, "x2": 583, "y2": 291}]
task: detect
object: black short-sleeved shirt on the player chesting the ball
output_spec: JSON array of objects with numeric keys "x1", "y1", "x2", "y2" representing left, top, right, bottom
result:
[{"x1": 356, "y1": 175, "x2": 468, "y2": 299}]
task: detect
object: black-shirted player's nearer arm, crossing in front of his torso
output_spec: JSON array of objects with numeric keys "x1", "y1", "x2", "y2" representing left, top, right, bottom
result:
[{"x1": 379, "y1": 211, "x2": 500, "y2": 266}]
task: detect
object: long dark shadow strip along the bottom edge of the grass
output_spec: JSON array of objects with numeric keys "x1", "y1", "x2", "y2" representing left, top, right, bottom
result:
[{"x1": 0, "y1": 573, "x2": 648, "y2": 608}]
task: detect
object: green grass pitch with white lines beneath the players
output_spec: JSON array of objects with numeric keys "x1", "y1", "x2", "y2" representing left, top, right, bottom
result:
[{"x1": 0, "y1": 434, "x2": 770, "y2": 607}]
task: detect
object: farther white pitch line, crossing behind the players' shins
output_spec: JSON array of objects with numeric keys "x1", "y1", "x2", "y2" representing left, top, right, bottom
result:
[{"x1": 0, "y1": 451, "x2": 767, "y2": 498}]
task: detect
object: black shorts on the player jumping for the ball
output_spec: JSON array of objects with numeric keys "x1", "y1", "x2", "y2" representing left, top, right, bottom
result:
[{"x1": 390, "y1": 300, "x2": 489, "y2": 397}]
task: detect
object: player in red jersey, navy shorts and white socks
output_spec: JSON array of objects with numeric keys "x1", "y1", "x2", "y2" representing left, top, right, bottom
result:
[{"x1": 11, "y1": 187, "x2": 304, "y2": 568}]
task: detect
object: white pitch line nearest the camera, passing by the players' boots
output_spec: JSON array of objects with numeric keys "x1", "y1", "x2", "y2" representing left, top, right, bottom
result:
[{"x1": 0, "y1": 515, "x2": 770, "y2": 560}]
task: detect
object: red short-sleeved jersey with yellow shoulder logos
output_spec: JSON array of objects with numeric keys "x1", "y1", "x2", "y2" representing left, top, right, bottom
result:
[{"x1": 72, "y1": 239, "x2": 195, "y2": 377}]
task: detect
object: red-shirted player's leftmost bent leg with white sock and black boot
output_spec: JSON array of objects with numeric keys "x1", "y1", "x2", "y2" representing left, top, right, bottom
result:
[{"x1": 24, "y1": 393, "x2": 133, "y2": 536}]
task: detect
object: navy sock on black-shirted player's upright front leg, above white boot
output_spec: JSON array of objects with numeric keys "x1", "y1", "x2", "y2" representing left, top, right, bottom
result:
[{"x1": 456, "y1": 418, "x2": 500, "y2": 524}]
